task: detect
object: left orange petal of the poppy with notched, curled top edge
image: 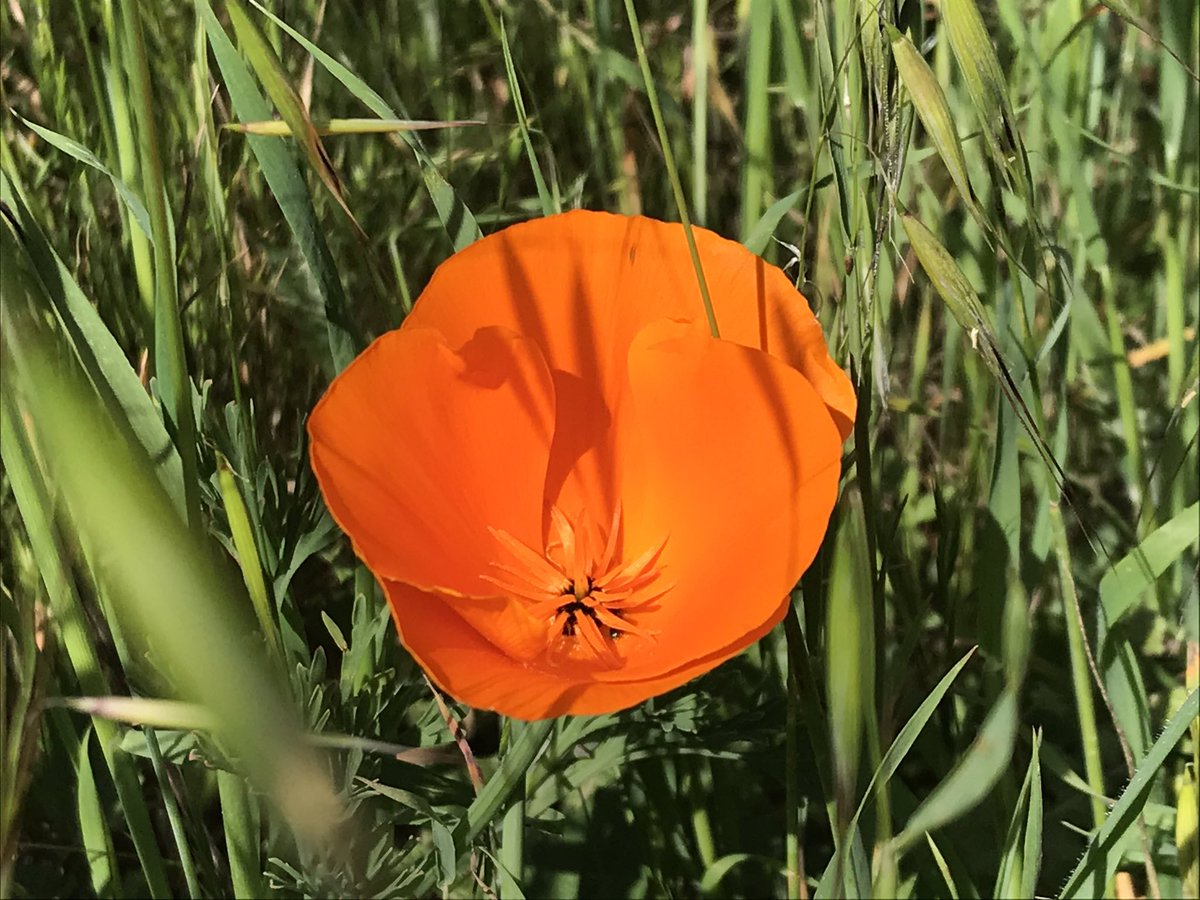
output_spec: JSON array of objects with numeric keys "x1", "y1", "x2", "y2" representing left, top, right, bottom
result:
[{"x1": 308, "y1": 328, "x2": 554, "y2": 596}]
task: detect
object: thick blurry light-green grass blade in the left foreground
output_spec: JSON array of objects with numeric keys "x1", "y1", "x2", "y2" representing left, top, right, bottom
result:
[{"x1": 6, "y1": 320, "x2": 353, "y2": 863}]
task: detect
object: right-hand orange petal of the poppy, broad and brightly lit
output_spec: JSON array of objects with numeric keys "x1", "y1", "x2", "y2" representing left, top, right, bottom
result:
[{"x1": 596, "y1": 322, "x2": 841, "y2": 680}]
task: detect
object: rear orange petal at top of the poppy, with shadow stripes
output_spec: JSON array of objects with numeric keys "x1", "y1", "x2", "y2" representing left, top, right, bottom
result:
[{"x1": 406, "y1": 210, "x2": 856, "y2": 441}]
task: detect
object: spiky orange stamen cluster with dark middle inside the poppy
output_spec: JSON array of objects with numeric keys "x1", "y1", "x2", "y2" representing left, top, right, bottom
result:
[{"x1": 484, "y1": 505, "x2": 668, "y2": 666}]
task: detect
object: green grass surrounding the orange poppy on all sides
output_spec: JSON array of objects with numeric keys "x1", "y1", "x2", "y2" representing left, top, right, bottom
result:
[{"x1": 0, "y1": 0, "x2": 1200, "y2": 898}]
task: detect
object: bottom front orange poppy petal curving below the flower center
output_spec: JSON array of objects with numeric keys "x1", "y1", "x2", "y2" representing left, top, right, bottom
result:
[{"x1": 383, "y1": 581, "x2": 788, "y2": 721}]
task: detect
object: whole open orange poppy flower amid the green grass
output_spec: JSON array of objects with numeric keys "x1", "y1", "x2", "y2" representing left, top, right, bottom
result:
[{"x1": 308, "y1": 211, "x2": 856, "y2": 719}]
